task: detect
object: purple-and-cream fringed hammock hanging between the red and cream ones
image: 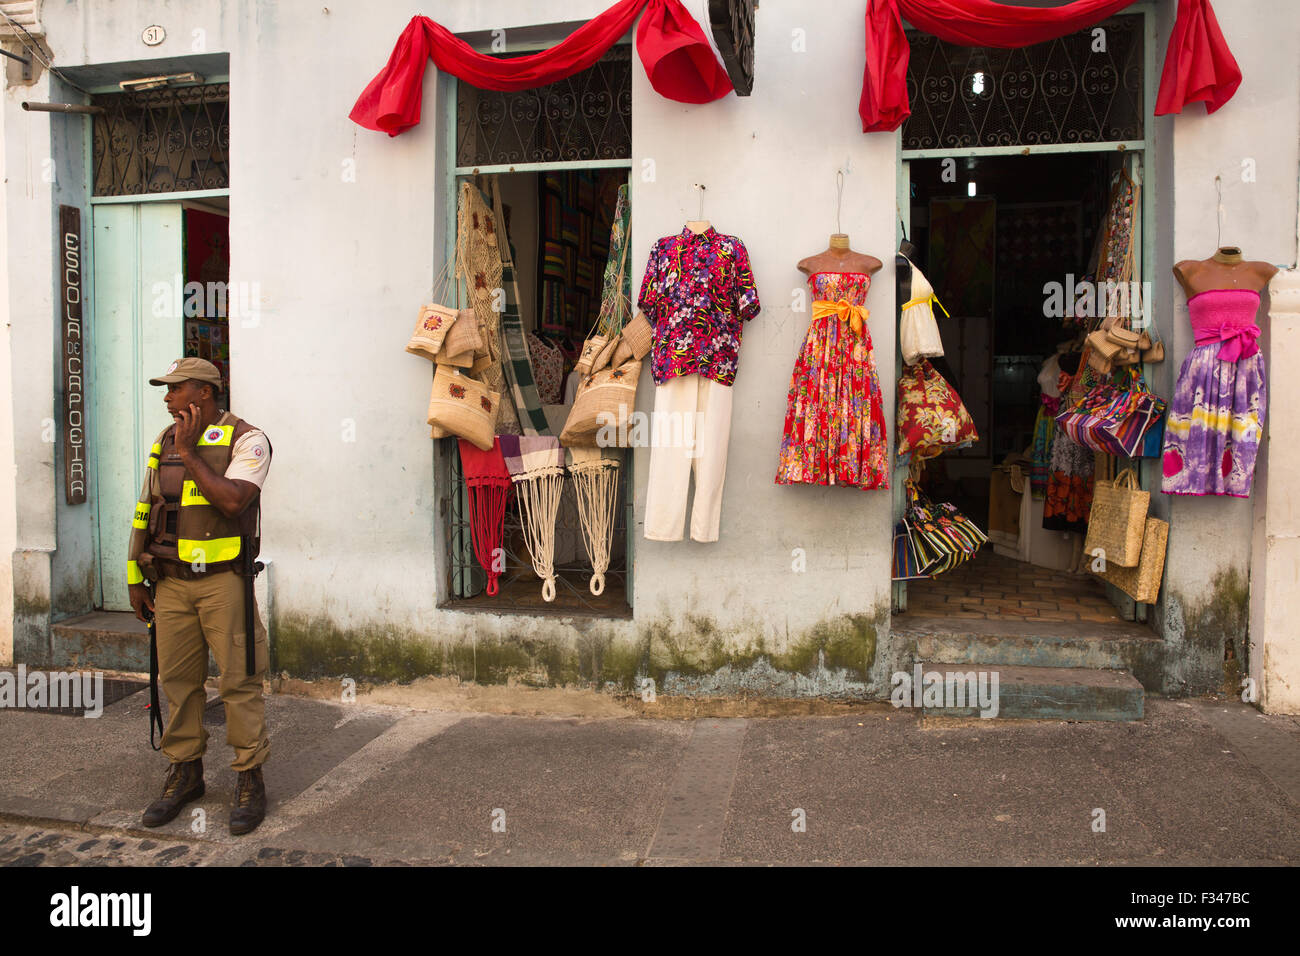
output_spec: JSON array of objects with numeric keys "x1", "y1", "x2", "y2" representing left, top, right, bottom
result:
[{"x1": 497, "y1": 434, "x2": 564, "y2": 601}]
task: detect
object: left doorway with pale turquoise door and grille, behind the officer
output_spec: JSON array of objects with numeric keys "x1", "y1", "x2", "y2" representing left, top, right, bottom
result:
[{"x1": 87, "y1": 78, "x2": 231, "y2": 611}]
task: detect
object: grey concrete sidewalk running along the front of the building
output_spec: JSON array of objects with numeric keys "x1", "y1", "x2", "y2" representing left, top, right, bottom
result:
[{"x1": 0, "y1": 691, "x2": 1300, "y2": 865}]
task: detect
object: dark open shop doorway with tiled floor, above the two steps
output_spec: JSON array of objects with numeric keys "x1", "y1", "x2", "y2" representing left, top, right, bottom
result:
[{"x1": 893, "y1": 13, "x2": 1156, "y2": 622}]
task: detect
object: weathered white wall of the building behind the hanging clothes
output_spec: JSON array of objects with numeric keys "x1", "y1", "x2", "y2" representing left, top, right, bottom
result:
[{"x1": 0, "y1": 0, "x2": 1300, "y2": 689}]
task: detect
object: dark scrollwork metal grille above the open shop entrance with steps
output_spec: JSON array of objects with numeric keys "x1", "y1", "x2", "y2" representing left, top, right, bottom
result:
[{"x1": 902, "y1": 16, "x2": 1144, "y2": 150}]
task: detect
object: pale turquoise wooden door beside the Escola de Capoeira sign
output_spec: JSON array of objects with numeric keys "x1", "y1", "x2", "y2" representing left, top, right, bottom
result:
[{"x1": 91, "y1": 203, "x2": 185, "y2": 611}]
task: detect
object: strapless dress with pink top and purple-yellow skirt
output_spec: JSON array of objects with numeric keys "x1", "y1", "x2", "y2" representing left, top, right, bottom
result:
[{"x1": 1161, "y1": 289, "x2": 1268, "y2": 498}]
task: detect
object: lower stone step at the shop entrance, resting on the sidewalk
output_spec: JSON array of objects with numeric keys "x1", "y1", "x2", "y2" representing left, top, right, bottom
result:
[{"x1": 905, "y1": 661, "x2": 1145, "y2": 721}]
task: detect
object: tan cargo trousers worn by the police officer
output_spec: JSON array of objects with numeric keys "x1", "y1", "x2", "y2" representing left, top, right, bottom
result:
[{"x1": 153, "y1": 571, "x2": 270, "y2": 770}]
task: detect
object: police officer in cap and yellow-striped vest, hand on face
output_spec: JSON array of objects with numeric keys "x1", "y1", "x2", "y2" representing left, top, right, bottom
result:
[{"x1": 126, "y1": 358, "x2": 270, "y2": 834}]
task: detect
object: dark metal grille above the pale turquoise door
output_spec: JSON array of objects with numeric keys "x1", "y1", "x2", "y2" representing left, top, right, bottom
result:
[{"x1": 92, "y1": 83, "x2": 230, "y2": 196}]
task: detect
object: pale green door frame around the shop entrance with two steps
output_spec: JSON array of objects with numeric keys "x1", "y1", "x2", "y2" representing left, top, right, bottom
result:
[{"x1": 889, "y1": 0, "x2": 1157, "y2": 622}]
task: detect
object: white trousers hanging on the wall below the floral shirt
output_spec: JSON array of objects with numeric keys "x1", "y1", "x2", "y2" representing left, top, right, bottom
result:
[{"x1": 645, "y1": 375, "x2": 732, "y2": 541}]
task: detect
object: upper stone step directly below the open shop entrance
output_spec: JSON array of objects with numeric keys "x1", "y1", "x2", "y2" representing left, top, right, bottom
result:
[{"x1": 893, "y1": 615, "x2": 1164, "y2": 689}]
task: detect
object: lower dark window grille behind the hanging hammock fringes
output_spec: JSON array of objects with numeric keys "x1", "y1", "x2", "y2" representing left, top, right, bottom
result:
[{"x1": 445, "y1": 441, "x2": 632, "y2": 617}]
